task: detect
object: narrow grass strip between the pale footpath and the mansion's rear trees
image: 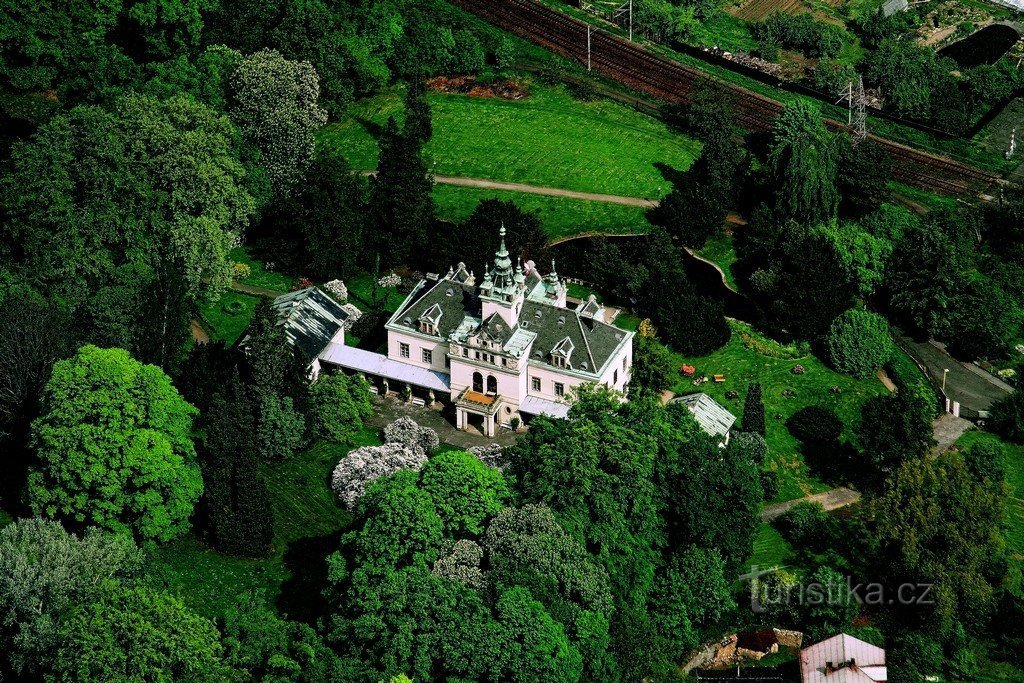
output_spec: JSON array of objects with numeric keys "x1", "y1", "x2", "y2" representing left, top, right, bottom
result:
[{"x1": 434, "y1": 185, "x2": 650, "y2": 240}]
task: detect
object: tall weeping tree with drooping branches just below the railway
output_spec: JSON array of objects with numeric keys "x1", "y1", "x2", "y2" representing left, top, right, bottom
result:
[{"x1": 768, "y1": 100, "x2": 839, "y2": 224}]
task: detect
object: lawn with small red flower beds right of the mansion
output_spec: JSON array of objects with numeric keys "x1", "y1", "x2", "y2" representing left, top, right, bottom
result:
[{"x1": 673, "y1": 323, "x2": 886, "y2": 502}]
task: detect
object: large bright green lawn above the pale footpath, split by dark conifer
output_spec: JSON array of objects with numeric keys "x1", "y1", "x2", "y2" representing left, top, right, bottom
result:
[{"x1": 318, "y1": 82, "x2": 699, "y2": 198}]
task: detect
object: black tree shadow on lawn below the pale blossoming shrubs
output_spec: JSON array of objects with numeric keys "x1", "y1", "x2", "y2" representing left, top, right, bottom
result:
[{"x1": 276, "y1": 529, "x2": 346, "y2": 626}]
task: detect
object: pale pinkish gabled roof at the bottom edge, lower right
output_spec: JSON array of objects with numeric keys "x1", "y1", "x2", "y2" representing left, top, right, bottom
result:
[{"x1": 800, "y1": 633, "x2": 888, "y2": 683}]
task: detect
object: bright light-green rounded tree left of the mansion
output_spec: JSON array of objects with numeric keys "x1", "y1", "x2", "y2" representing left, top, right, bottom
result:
[{"x1": 28, "y1": 346, "x2": 203, "y2": 541}]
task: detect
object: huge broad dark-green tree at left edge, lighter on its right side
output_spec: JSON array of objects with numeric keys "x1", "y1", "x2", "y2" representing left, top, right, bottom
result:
[{"x1": 0, "y1": 95, "x2": 254, "y2": 365}]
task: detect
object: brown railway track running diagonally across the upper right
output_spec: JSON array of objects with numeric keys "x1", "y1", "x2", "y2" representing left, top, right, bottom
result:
[{"x1": 453, "y1": 0, "x2": 999, "y2": 197}]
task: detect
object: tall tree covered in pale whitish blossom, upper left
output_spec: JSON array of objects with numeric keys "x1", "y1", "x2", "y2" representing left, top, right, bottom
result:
[{"x1": 230, "y1": 49, "x2": 327, "y2": 198}]
